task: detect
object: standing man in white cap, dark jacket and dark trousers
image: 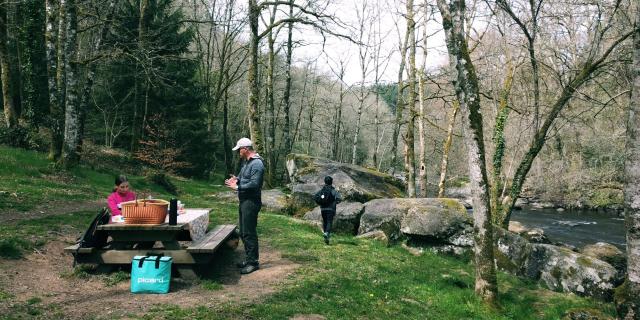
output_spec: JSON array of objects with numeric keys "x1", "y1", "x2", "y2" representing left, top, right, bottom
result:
[{"x1": 224, "y1": 138, "x2": 264, "y2": 274}]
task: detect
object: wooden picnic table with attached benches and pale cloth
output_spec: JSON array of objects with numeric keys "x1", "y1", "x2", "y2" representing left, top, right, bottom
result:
[{"x1": 64, "y1": 209, "x2": 236, "y2": 279}]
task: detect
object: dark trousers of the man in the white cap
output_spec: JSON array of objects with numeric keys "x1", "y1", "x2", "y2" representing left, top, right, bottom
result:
[{"x1": 238, "y1": 199, "x2": 262, "y2": 265}]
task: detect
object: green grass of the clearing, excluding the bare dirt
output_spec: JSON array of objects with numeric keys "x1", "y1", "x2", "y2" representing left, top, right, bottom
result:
[{"x1": 0, "y1": 147, "x2": 615, "y2": 319}]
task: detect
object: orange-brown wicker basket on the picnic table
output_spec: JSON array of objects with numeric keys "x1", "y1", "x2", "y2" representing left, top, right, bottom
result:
[{"x1": 121, "y1": 199, "x2": 169, "y2": 224}]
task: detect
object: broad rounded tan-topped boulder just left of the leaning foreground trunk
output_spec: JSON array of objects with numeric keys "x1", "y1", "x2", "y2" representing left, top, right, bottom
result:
[{"x1": 358, "y1": 198, "x2": 470, "y2": 240}]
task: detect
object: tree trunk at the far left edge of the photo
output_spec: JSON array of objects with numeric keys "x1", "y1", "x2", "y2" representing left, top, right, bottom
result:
[{"x1": 0, "y1": 0, "x2": 18, "y2": 129}]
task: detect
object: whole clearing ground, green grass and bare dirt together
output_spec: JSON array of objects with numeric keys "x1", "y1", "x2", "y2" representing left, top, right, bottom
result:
[{"x1": 0, "y1": 148, "x2": 615, "y2": 319}]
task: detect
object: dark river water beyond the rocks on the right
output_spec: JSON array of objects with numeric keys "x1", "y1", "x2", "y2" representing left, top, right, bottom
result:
[{"x1": 511, "y1": 208, "x2": 625, "y2": 251}]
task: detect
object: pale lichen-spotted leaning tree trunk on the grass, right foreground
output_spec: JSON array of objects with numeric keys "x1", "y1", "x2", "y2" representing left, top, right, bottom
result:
[{"x1": 437, "y1": 0, "x2": 498, "y2": 304}]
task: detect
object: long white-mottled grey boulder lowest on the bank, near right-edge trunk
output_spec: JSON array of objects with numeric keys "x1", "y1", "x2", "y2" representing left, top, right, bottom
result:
[{"x1": 524, "y1": 244, "x2": 621, "y2": 301}]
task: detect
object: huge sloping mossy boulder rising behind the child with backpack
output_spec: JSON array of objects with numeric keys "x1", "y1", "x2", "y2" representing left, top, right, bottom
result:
[{"x1": 287, "y1": 154, "x2": 405, "y2": 210}]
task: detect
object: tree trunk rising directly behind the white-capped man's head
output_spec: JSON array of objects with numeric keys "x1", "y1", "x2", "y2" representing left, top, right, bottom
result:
[{"x1": 247, "y1": 0, "x2": 263, "y2": 152}]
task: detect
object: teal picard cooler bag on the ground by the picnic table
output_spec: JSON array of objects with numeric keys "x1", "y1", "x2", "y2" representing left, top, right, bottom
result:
[{"x1": 131, "y1": 256, "x2": 173, "y2": 293}]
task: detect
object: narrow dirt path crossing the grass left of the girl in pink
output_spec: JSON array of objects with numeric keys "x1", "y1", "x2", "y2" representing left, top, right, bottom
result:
[{"x1": 0, "y1": 199, "x2": 107, "y2": 223}]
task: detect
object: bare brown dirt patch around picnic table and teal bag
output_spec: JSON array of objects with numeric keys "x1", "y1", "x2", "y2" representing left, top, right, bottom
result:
[{"x1": 0, "y1": 238, "x2": 298, "y2": 319}]
